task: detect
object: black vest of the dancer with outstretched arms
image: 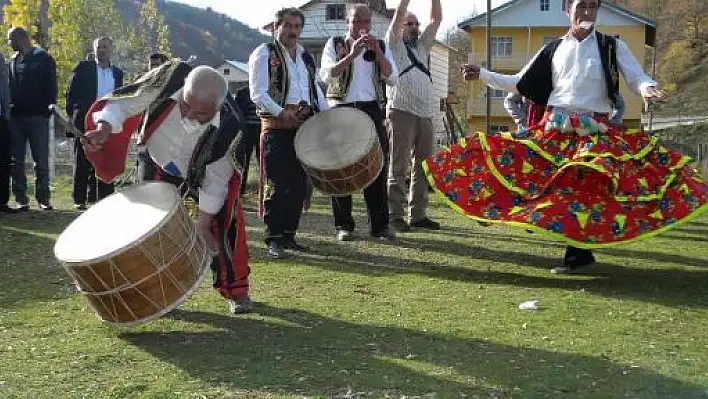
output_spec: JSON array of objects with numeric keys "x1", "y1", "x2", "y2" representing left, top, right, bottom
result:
[{"x1": 516, "y1": 31, "x2": 619, "y2": 106}]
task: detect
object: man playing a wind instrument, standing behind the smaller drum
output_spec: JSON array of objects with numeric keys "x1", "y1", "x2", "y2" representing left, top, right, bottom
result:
[{"x1": 320, "y1": 4, "x2": 398, "y2": 241}]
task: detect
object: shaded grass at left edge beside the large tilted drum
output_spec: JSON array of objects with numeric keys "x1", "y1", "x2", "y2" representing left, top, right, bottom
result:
[{"x1": 0, "y1": 211, "x2": 76, "y2": 309}]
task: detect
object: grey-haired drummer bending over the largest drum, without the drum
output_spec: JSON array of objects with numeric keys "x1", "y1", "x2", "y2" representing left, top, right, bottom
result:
[{"x1": 83, "y1": 61, "x2": 253, "y2": 313}]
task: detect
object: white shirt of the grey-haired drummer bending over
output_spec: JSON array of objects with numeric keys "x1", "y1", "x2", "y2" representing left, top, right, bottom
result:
[{"x1": 93, "y1": 89, "x2": 234, "y2": 215}]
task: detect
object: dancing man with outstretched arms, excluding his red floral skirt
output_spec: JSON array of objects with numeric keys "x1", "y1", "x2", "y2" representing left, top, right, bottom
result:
[{"x1": 462, "y1": 0, "x2": 665, "y2": 273}]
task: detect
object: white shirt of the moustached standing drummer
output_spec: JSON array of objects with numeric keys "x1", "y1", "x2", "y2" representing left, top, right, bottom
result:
[{"x1": 248, "y1": 41, "x2": 327, "y2": 116}]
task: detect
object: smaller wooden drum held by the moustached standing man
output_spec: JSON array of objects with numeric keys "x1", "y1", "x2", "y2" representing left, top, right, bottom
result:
[{"x1": 295, "y1": 107, "x2": 383, "y2": 196}]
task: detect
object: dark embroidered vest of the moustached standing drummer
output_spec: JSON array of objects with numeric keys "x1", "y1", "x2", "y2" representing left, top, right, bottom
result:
[{"x1": 258, "y1": 43, "x2": 320, "y2": 116}]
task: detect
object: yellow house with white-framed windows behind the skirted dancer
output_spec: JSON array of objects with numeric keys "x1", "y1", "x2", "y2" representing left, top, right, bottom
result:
[{"x1": 458, "y1": 0, "x2": 656, "y2": 131}]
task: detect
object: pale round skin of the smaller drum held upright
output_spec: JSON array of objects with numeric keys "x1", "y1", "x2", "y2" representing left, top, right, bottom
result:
[{"x1": 295, "y1": 107, "x2": 378, "y2": 170}]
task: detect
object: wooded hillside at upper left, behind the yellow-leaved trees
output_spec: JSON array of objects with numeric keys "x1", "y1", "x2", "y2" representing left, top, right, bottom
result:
[{"x1": 0, "y1": 0, "x2": 269, "y2": 65}]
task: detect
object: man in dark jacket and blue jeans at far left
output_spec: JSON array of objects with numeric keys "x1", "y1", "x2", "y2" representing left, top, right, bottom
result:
[{"x1": 7, "y1": 28, "x2": 57, "y2": 211}]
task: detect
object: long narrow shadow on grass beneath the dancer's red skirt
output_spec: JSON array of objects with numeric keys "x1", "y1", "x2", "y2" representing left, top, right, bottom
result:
[{"x1": 301, "y1": 245, "x2": 708, "y2": 308}]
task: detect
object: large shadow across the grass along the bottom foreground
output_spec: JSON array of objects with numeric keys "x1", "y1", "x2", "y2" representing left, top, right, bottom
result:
[{"x1": 120, "y1": 304, "x2": 705, "y2": 398}]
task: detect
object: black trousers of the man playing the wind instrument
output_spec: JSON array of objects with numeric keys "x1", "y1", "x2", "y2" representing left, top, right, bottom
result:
[{"x1": 332, "y1": 101, "x2": 389, "y2": 234}]
